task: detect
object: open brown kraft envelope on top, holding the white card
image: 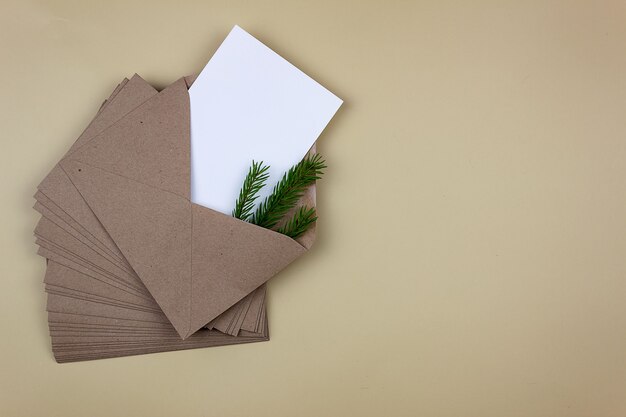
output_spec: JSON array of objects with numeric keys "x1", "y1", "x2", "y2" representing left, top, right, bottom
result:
[{"x1": 60, "y1": 78, "x2": 314, "y2": 339}]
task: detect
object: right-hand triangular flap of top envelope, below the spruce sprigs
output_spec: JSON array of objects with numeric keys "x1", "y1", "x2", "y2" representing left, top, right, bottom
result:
[{"x1": 189, "y1": 204, "x2": 306, "y2": 334}]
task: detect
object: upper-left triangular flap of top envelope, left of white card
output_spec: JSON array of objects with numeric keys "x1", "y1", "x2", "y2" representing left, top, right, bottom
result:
[{"x1": 64, "y1": 78, "x2": 190, "y2": 199}]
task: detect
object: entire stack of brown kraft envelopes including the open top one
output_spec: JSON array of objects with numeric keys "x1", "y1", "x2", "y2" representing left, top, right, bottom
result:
[{"x1": 35, "y1": 75, "x2": 315, "y2": 362}]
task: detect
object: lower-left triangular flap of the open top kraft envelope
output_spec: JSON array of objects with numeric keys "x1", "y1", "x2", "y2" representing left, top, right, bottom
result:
[{"x1": 61, "y1": 158, "x2": 191, "y2": 337}]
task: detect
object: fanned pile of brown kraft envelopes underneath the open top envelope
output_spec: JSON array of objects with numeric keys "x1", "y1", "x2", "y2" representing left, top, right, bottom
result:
[{"x1": 36, "y1": 76, "x2": 300, "y2": 362}]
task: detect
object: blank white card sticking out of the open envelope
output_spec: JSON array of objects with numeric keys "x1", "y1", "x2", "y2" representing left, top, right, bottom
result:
[{"x1": 189, "y1": 26, "x2": 342, "y2": 215}]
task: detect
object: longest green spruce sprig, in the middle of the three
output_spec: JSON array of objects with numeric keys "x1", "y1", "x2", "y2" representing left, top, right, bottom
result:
[{"x1": 249, "y1": 154, "x2": 326, "y2": 229}]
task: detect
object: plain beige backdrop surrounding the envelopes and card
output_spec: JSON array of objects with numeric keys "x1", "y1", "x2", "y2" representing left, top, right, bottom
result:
[{"x1": 0, "y1": 0, "x2": 626, "y2": 417}]
